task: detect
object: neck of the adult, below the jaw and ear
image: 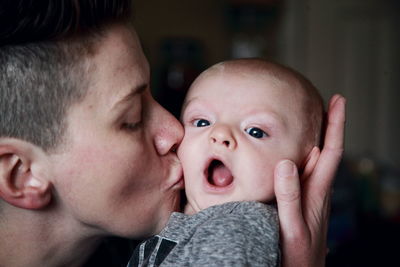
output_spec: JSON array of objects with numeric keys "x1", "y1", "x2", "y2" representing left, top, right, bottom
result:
[{"x1": 0, "y1": 207, "x2": 100, "y2": 267}]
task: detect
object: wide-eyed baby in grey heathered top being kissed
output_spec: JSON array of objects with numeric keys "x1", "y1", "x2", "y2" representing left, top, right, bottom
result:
[{"x1": 128, "y1": 59, "x2": 323, "y2": 266}]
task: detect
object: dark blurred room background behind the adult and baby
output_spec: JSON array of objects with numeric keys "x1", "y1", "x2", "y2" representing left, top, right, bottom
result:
[{"x1": 89, "y1": 0, "x2": 400, "y2": 266}]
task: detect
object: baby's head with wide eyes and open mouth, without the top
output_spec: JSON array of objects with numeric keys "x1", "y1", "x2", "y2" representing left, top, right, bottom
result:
[{"x1": 178, "y1": 59, "x2": 323, "y2": 216}]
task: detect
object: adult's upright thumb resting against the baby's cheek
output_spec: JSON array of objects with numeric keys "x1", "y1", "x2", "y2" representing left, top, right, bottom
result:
[{"x1": 274, "y1": 160, "x2": 306, "y2": 238}]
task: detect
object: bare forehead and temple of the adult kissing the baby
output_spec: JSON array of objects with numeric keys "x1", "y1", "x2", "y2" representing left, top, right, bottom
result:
[{"x1": 80, "y1": 25, "x2": 150, "y2": 105}]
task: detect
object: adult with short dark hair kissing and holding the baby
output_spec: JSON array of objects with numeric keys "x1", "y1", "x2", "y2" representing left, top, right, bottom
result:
[{"x1": 0, "y1": 0, "x2": 344, "y2": 266}]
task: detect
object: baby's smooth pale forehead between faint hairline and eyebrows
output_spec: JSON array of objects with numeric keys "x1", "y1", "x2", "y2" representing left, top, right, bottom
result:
[{"x1": 188, "y1": 71, "x2": 304, "y2": 109}]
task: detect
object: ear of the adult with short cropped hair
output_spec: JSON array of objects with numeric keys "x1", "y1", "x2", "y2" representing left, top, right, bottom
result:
[{"x1": 0, "y1": 138, "x2": 51, "y2": 209}]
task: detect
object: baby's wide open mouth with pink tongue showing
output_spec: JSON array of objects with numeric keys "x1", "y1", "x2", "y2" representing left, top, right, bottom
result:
[{"x1": 206, "y1": 159, "x2": 233, "y2": 187}]
